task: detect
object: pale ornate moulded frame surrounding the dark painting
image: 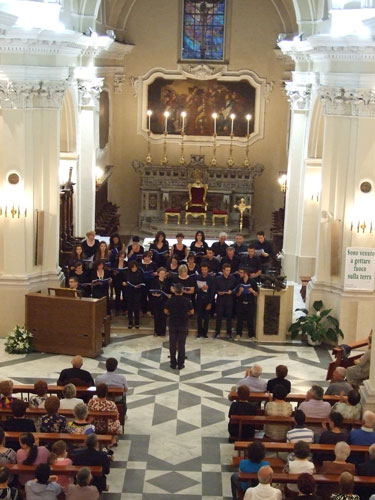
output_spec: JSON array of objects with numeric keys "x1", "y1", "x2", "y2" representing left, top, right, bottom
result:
[{"x1": 135, "y1": 64, "x2": 273, "y2": 147}]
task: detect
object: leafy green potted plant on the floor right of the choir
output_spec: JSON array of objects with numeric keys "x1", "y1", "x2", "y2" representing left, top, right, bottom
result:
[{"x1": 288, "y1": 300, "x2": 344, "y2": 345}]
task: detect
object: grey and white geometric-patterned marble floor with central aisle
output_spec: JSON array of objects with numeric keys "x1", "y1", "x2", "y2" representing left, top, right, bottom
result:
[{"x1": 0, "y1": 324, "x2": 346, "y2": 500}]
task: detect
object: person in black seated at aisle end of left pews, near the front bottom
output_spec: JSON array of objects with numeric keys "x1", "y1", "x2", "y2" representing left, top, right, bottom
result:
[{"x1": 73, "y1": 434, "x2": 109, "y2": 493}]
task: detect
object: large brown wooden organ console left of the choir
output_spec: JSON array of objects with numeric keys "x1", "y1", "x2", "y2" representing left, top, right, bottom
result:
[{"x1": 25, "y1": 293, "x2": 107, "y2": 358}]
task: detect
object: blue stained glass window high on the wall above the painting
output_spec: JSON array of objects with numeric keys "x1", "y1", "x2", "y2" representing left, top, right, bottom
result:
[{"x1": 182, "y1": 0, "x2": 225, "y2": 61}]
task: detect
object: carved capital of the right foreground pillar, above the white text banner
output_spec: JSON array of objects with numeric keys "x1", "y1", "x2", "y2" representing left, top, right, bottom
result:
[{"x1": 318, "y1": 85, "x2": 375, "y2": 117}]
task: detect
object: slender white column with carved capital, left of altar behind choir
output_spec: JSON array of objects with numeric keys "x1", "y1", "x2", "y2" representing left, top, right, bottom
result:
[{"x1": 75, "y1": 78, "x2": 103, "y2": 236}]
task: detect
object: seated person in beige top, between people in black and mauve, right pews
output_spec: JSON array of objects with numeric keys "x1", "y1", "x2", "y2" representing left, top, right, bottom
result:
[{"x1": 264, "y1": 385, "x2": 293, "y2": 441}]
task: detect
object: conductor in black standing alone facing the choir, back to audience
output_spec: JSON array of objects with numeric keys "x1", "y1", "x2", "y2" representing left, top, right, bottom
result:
[{"x1": 164, "y1": 283, "x2": 194, "y2": 370}]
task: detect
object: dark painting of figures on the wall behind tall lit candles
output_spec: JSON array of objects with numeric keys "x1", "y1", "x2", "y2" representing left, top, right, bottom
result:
[{"x1": 147, "y1": 77, "x2": 256, "y2": 137}]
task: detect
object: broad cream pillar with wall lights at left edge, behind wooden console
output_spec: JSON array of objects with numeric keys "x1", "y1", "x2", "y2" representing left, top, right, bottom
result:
[{"x1": 0, "y1": 75, "x2": 68, "y2": 336}]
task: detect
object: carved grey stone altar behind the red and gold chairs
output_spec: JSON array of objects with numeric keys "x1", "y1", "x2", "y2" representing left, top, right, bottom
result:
[{"x1": 132, "y1": 155, "x2": 264, "y2": 235}]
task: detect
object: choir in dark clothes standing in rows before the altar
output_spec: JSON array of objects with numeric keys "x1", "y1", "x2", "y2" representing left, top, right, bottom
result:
[{"x1": 68, "y1": 231, "x2": 273, "y2": 340}]
